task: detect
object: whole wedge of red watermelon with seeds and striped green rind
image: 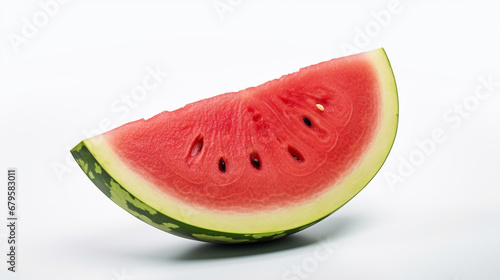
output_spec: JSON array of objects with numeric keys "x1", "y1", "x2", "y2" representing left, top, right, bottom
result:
[{"x1": 71, "y1": 49, "x2": 398, "y2": 243}]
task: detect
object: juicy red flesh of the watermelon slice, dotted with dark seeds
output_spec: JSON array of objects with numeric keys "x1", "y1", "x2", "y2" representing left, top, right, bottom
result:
[{"x1": 108, "y1": 58, "x2": 378, "y2": 212}]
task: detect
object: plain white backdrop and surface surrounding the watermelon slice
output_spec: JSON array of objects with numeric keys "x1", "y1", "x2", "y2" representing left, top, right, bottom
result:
[{"x1": 0, "y1": 0, "x2": 500, "y2": 280}]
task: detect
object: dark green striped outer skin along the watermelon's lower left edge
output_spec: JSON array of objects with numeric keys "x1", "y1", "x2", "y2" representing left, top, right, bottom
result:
[{"x1": 71, "y1": 140, "x2": 318, "y2": 244}]
